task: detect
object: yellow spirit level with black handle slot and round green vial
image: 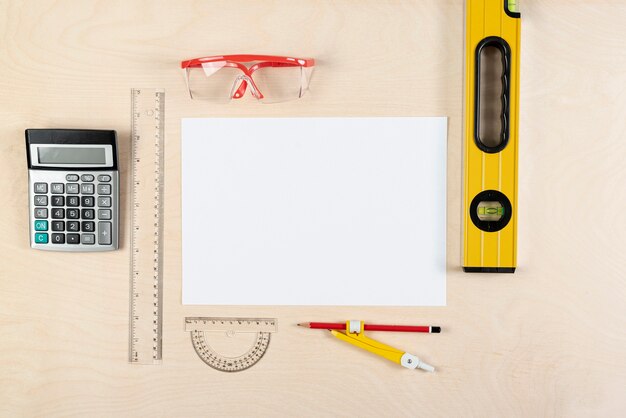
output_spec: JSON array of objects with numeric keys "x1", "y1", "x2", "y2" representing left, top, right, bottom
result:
[{"x1": 463, "y1": 0, "x2": 521, "y2": 273}]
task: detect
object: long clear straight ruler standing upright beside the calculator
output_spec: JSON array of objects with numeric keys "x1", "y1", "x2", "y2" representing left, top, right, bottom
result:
[{"x1": 129, "y1": 89, "x2": 165, "y2": 364}]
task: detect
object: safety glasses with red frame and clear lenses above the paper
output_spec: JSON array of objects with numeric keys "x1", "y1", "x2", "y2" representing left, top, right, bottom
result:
[{"x1": 180, "y1": 55, "x2": 315, "y2": 103}]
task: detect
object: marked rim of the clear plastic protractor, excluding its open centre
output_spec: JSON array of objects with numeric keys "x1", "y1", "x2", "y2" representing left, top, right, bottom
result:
[{"x1": 185, "y1": 317, "x2": 277, "y2": 372}]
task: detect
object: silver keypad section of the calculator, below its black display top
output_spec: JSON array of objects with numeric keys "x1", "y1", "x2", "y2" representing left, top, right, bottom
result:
[{"x1": 31, "y1": 172, "x2": 118, "y2": 251}]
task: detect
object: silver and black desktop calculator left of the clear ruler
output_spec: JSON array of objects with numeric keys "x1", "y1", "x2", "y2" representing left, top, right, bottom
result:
[{"x1": 26, "y1": 129, "x2": 119, "y2": 251}]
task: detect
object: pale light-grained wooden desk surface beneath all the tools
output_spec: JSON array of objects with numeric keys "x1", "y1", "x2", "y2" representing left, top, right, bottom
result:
[{"x1": 0, "y1": 0, "x2": 626, "y2": 417}]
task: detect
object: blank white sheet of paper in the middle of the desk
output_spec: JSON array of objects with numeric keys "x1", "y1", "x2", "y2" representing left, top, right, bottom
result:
[{"x1": 182, "y1": 117, "x2": 447, "y2": 306}]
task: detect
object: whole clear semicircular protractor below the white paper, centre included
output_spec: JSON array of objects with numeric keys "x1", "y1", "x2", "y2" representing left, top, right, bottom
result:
[{"x1": 185, "y1": 317, "x2": 276, "y2": 372}]
